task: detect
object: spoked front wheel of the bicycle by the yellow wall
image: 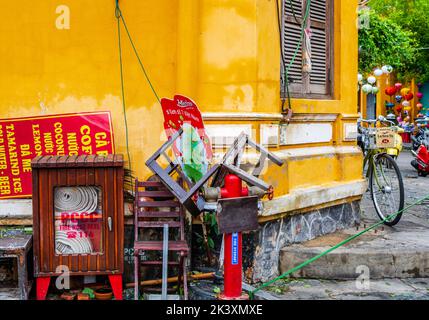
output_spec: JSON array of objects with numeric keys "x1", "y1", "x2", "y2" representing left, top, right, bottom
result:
[{"x1": 369, "y1": 153, "x2": 404, "y2": 226}]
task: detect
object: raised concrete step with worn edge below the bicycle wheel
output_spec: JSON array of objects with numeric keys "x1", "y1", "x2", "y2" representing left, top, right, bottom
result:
[{"x1": 279, "y1": 222, "x2": 429, "y2": 279}]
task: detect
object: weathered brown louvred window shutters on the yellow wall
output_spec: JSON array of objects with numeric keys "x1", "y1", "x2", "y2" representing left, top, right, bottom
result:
[{"x1": 281, "y1": 0, "x2": 333, "y2": 98}]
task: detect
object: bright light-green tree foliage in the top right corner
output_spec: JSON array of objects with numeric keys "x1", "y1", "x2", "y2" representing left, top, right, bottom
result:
[{"x1": 362, "y1": 0, "x2": 429, "y2": 82}]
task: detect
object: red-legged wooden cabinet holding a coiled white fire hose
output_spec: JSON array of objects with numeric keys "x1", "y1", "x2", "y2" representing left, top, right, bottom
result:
[{"x1": 31, "y1": 155, "x2": 124, "y2": 299}]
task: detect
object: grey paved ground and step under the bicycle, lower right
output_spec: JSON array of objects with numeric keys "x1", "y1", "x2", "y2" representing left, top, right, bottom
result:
[{"x1": 267, "y1": 150, "x2": 429, "y2": 300}]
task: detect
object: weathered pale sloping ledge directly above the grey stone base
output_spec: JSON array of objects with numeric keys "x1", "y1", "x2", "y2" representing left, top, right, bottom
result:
[{"x1": 261, "y1": 179, "x2": 367, "y2": 217}]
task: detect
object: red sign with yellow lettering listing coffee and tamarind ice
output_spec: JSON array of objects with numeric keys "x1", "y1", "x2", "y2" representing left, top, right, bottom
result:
[{"x1": 0, "y1": 111, "x2": 115, "y2": 199}]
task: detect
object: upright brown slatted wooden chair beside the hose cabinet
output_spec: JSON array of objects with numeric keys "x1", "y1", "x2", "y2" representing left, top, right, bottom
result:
[{"x1": 134, "y1": 179, "x2": 189, "y2": 300}]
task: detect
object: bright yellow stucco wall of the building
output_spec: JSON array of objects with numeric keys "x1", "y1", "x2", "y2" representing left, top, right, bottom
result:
[{"x1": 0, "y1": 0, "x2": 362, "y2": 218}]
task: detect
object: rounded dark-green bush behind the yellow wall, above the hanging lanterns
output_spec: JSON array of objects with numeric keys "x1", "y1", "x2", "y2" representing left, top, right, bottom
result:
[{"x1": 359, "y1": 10, "x2": 417, "y2": 80}]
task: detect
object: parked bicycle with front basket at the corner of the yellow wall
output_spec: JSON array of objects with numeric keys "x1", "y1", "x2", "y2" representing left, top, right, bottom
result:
[{"x1": 359, "y1": 116, "x2": 405, "y2": 226}]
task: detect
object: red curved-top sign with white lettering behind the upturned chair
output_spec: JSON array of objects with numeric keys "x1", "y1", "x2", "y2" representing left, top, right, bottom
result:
[{"x1": 161, "y1": 95, "x2": 213, "y2": 159}]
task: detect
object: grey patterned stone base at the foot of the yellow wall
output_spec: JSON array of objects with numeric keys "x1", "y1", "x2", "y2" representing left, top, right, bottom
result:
[{"x1": 243, "y1": 201, "x2": 360, "y2": 283}]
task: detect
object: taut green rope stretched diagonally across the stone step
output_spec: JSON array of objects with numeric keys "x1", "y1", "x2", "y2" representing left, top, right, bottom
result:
[{"x1": 249, "y1": 195, "x2": 429, "y2": 299}]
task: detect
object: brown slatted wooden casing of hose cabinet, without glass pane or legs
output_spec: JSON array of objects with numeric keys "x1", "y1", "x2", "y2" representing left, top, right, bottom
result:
[{"x1": 31, "y1": 155, "x2": 124, "y2": 277}]
